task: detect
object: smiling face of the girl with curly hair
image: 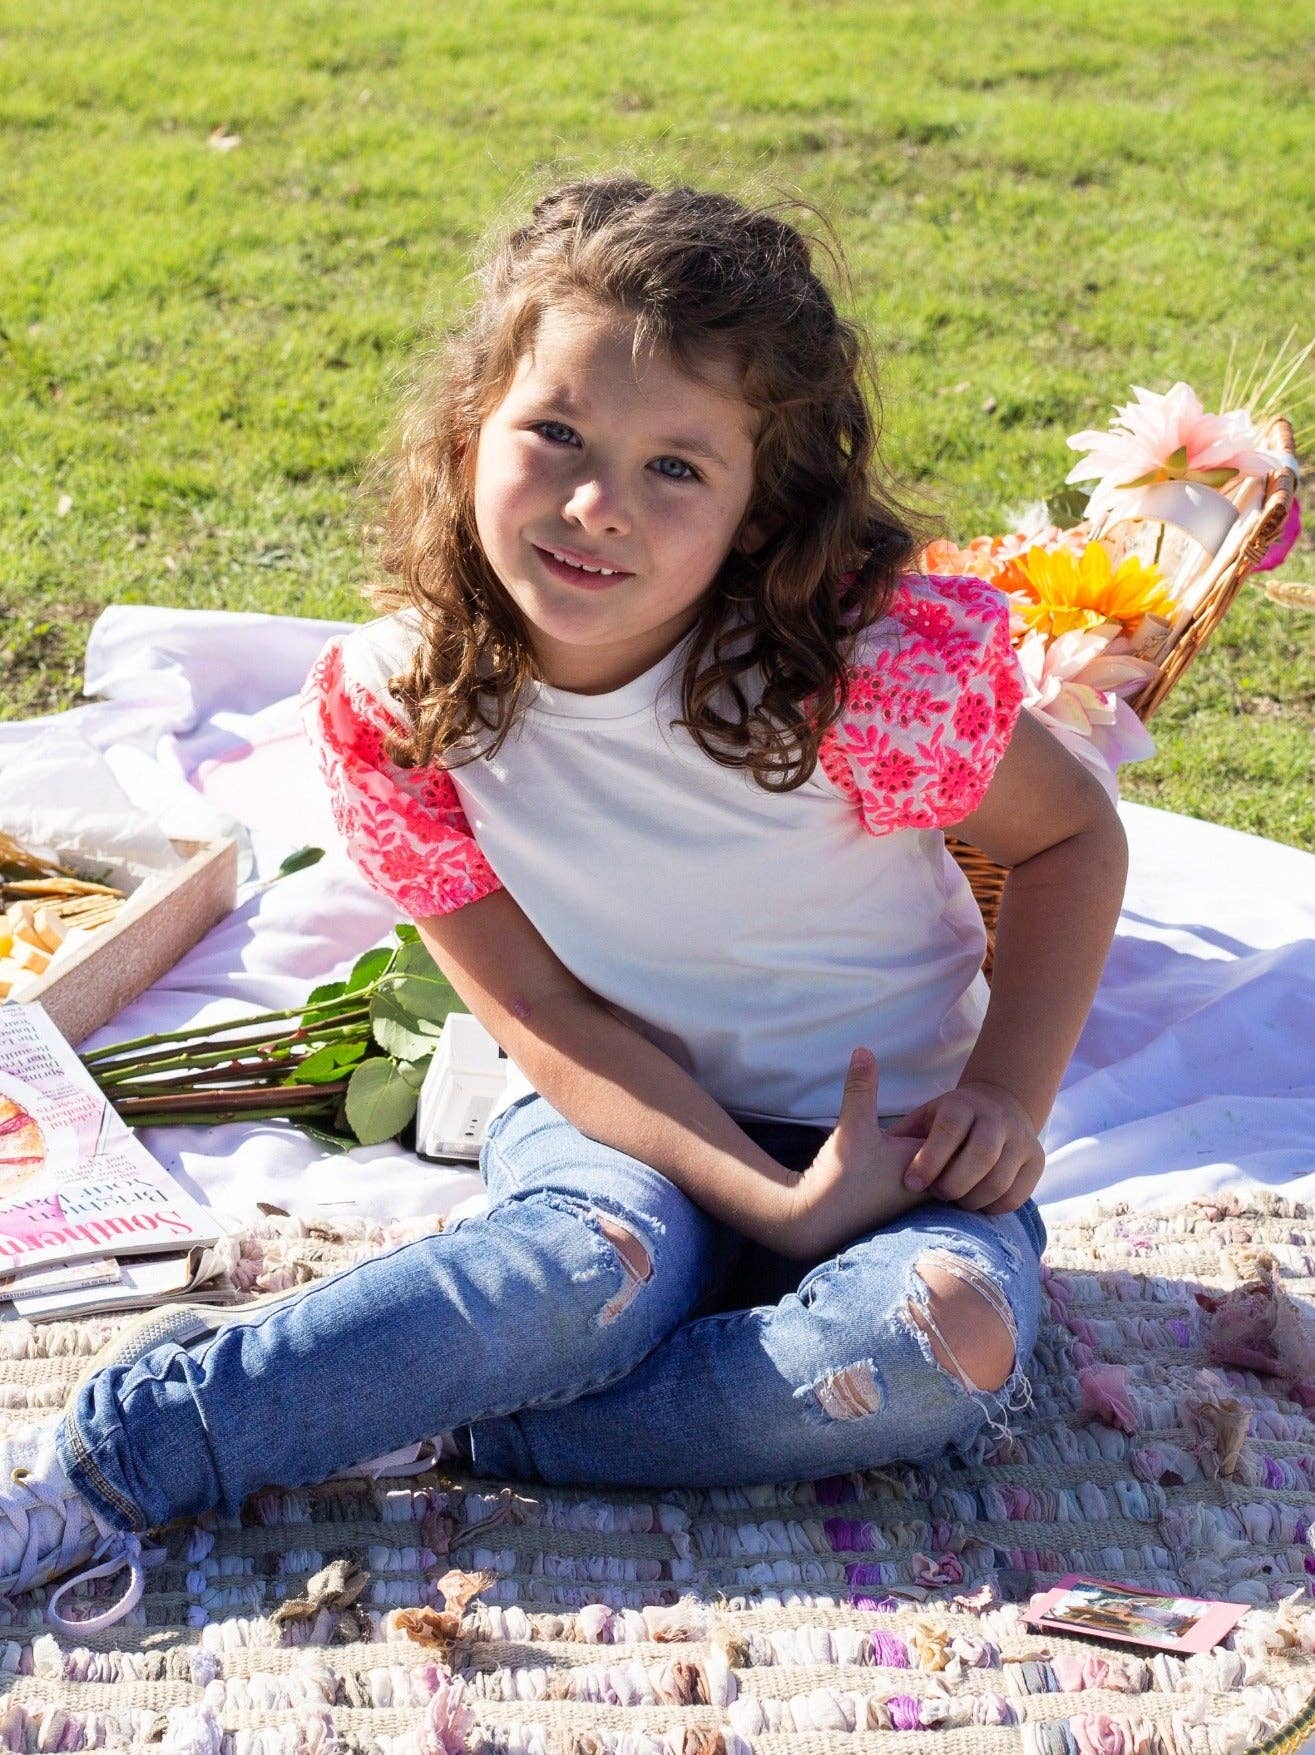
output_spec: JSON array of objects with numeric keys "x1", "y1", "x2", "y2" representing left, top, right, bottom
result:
[{"x1": 474, "y1": 309, "x2": 760, "y2": 695}]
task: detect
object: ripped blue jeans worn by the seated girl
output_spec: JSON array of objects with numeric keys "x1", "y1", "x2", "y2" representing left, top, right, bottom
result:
[{"x1": 58, "y1": 1095, "x2": 1046, "y2": 1530}]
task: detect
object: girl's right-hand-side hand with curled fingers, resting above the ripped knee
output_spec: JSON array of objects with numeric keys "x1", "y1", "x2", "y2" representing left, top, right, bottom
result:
[{"x1": 887, "y1": 1079, "x2": 1046, "y2": 1214}]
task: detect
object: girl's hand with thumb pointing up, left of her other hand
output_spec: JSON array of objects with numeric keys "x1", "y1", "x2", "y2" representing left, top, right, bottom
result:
[{"x1": 772, "y1": 1048, "x2": 927, "y2": 1262}]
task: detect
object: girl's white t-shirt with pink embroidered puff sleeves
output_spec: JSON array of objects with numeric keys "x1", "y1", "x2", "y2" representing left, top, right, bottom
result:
[{"x1": 304, "y1": 574, "x2": 1022, "y2": 1127}]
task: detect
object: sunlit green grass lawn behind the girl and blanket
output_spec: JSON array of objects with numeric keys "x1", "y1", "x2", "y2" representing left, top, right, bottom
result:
[{"x1": 0, "y1": 0, "x2": 1315, "y2": 849}]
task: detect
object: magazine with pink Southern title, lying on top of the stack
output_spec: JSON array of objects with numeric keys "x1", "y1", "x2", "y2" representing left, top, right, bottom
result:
[{"x1": 0, "y1": 1000, "x2": 223, "y2": 1297}]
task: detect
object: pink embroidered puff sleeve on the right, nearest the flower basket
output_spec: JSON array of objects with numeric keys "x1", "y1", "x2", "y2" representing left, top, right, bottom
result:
[{"x1": 818, "y1": 574, "x2": 1025, "y2": 835}]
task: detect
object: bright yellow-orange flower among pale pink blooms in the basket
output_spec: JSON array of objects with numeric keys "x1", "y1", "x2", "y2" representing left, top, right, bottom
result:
[{"x1": 995, "y1": 542, "x2": 1178, "y2": 639}]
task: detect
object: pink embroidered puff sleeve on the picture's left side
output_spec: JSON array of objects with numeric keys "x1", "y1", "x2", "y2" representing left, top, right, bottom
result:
[{"x1": 300, "y1": 628, "x2": 502, "y2": 920}]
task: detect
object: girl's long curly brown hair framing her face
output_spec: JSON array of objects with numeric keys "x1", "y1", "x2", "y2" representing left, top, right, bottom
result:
[{"x1": 365, "y1": 174, "x2": 936, "y2": 792}]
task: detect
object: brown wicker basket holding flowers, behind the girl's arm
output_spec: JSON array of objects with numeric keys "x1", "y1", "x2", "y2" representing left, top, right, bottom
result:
[{"x1": 946, "y1": 419, "x2": 1297, "y2": 978}]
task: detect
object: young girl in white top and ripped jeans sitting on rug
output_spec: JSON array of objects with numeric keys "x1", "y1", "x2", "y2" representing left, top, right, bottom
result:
[{"x1": 0, "y1": 176, "x2": 1125, "y2": 1627}]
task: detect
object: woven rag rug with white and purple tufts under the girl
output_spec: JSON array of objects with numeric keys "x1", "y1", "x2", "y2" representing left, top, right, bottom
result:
[{"x1": 0, "y1": 1193, "x2": 1315, "y2": 1755}]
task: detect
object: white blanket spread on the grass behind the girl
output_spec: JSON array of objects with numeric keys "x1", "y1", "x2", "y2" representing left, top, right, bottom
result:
[{"x1": 0, "y1": 605, "x2": 1315, "y2": 1220}]
